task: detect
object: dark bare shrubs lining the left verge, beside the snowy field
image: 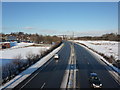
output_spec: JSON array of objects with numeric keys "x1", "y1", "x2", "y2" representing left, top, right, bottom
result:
[{"x1": 1, "y1": 42, "x2": 62, "y2": 84}]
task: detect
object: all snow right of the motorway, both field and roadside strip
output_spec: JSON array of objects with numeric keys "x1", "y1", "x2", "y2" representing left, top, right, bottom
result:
[{"x1": 74, "y1": 40, "x2": 120, "y2": 74}]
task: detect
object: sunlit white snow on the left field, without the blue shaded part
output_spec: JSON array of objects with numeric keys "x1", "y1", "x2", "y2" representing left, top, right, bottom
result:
[{"x1": 0, "y1": 47, "x2": 50, "y2": 59}]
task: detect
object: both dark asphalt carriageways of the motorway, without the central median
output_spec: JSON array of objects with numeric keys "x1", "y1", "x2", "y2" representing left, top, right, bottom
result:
[{"x1": 14, "y1": 42, "x2": 120, "y2": 89}]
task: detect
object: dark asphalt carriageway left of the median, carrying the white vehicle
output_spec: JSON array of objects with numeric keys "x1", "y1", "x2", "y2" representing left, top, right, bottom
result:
[{"x1": 14, "y1": 42, "x2": 71, "y2": 89}]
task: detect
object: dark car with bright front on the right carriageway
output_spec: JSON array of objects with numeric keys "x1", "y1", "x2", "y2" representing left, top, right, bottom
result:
[{"x1": 89, "y1": 73, "x2": 102, "y2": 88}]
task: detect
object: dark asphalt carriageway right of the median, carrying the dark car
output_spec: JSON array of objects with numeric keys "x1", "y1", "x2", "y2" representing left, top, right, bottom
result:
[{"x1": 74, "y1": 44, "x2": 120, "y2": 88}]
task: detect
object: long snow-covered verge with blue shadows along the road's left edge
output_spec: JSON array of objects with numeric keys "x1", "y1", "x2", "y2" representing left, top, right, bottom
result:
[{"x1": 0, "y1": 44, "x2": 64, "y2": 89}]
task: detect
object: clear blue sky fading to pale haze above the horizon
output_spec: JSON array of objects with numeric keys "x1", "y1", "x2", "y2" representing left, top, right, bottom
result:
[{"x1": 2, "y1": 2, "x2": 118, "y2": 36}]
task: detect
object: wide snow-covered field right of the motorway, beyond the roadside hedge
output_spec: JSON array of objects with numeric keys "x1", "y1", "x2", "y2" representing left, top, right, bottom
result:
[{"x1": 75, "y1": 40, "x2": 119, "y2": 60}]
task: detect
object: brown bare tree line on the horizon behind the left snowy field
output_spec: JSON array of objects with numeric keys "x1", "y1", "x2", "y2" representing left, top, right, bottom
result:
[{"x1": 1, "y1": 32, "x2": 62, "y2": 44}]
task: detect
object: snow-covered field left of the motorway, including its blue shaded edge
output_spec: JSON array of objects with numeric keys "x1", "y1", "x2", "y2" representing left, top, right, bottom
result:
[{"x1": 0, "y1": 43, "x2": 50, "y2": 65}]
